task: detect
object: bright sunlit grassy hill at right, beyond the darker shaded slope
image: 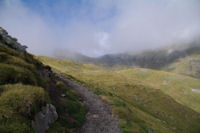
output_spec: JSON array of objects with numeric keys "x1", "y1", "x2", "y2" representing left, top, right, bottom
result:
[{"x1": 119, "y1": 68, "x2": 200, "y2": 112}]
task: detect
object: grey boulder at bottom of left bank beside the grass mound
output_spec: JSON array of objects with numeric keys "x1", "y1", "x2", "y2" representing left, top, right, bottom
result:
[{"x1": 31, "y1": 104, "x2": 58, "y2": 133}]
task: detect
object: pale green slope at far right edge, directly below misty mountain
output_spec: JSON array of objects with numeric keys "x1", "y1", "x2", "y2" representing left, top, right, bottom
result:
[{"x1": 164, "y1": 54, "x2": 200, "y2": 78}]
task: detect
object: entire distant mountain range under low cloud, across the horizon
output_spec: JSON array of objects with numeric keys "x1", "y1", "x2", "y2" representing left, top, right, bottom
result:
[{"x1": 54, "y1": 42, "x2": 200, "y2": 69}]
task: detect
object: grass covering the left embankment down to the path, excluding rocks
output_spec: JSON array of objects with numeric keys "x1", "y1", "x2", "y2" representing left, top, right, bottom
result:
[{"x1": 0, "y1": 46, "x2": 85, "y2": 133}]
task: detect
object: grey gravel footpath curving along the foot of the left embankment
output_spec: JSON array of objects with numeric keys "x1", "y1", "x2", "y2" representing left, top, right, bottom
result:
[{"x1": 59, "y1": 75, "x2": 121, "y2": 133}]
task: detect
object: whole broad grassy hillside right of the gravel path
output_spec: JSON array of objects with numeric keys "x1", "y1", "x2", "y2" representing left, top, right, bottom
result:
[{"x1": 38, "y1": 57, "x2": 200, "y2": 133}]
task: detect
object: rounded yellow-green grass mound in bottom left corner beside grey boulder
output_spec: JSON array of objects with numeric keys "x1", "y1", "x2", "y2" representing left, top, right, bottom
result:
[{"x1": 0, "y1": 84, "x2": 50, "y2": 133}]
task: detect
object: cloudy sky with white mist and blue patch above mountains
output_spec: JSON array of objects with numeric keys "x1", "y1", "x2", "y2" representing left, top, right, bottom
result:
[{"x1": 0, "y1": 0, "x2": 200, "y2": 57}]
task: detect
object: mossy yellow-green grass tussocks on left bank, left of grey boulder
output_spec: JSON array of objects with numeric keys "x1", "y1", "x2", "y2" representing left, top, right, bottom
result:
[{"x1": 0, "y1": 46, "x2": 50, "y2": 133}]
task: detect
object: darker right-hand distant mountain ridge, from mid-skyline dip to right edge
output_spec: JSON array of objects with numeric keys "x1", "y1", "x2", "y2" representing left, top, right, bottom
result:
[{"x1": 97, "y1": 43, "x2": 200, "y2": 69}]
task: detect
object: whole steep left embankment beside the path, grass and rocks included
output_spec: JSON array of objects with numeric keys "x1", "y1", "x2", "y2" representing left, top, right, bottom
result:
[{"x1": 0, "y1": 28, "x2": 85, "y2": 133}]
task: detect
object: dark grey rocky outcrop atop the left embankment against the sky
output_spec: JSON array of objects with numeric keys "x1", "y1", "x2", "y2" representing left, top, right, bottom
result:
[{"x1": 0, "y1": 27, "x2": 27, "y2": 53}]
